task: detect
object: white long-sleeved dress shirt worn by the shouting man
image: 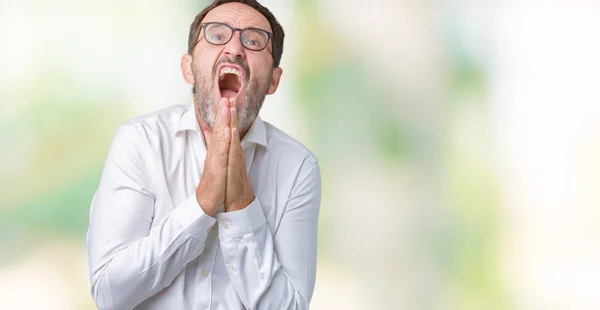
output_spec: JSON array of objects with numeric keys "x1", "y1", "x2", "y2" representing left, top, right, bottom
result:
[{"x1": 87, "y1": 105, "x2": 321, "y2": 309}]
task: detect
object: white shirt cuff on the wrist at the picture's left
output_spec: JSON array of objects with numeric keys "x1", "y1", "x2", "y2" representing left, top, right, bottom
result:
[{"x1": 171, "y1": 194, "x2": 217, "y2": 242}]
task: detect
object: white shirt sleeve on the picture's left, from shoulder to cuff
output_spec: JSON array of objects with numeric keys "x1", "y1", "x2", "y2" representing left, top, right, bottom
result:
[{"x1": 87, "y1": 124, "x2": 216, "y2": 309}]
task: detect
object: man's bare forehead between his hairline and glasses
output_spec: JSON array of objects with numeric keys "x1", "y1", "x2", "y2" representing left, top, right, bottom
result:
[{"x1": 202, "y1": 2, "x2": 272, "y2": 32}]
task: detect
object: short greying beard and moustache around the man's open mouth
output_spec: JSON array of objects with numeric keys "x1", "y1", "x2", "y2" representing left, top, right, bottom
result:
[{"x1": 192, "y1": 58, "x2": 273, "y2": 133}]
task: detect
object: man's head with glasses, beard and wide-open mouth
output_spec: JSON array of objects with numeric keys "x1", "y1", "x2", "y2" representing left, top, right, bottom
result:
[{"x1": 181, "y1": 0, "x2": 284, "y2": 132}]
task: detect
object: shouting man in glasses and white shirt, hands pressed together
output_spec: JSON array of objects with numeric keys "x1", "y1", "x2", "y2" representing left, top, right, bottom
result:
[{"x1": 88, "y1": 0, "x2": 321, "y2": 309}]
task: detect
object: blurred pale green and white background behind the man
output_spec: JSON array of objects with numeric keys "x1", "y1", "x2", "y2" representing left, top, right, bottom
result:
[{"x1": 0, "y1": 0, "x2": 600, "y2": 310}]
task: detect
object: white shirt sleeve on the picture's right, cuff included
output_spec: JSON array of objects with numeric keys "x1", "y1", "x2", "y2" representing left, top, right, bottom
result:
[{"x1": 217, "y1": 162, "x2": 321, "y2": 309}]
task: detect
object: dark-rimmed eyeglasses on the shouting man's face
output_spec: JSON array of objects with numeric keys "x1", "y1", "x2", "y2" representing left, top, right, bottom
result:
[{"x1": 200, "y1": 23, "x2": 273, "y2": 51}]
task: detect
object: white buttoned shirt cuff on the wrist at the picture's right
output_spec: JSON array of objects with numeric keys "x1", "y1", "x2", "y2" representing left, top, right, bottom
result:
[{"x1": 217, "y1": 198, "x2": 267, "y2": 238}]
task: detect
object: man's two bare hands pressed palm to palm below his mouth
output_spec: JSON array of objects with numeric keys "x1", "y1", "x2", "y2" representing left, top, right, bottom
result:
[{"x1": 196, "y1": 98, "x2": 255, "y2": 216}]
